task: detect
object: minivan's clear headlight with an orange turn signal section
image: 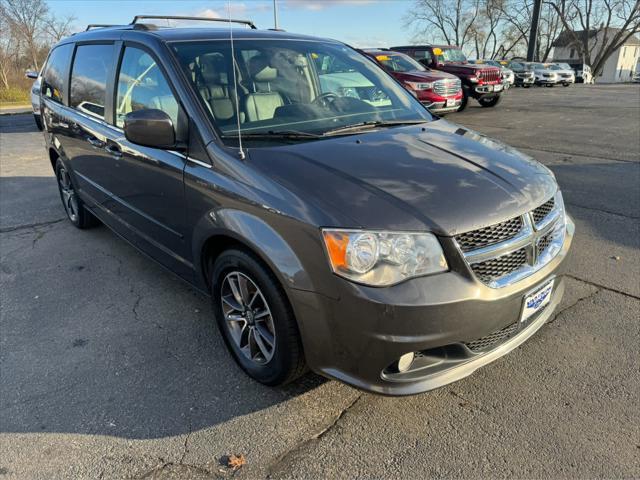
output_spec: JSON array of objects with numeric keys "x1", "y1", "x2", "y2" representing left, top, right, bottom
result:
[{"x1": 322, "y1": 229, "x2": 448, "y2": 287}]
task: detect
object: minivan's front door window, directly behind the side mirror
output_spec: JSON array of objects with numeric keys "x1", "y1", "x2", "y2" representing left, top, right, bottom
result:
[{"x1": 116, "y1": 47, "x2": 178, "y2": 127}]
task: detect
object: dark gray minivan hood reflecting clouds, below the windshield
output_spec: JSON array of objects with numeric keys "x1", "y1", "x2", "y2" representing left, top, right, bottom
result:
[{"x1": 248, "y1": 120, "x2": 557, "y2": 235}]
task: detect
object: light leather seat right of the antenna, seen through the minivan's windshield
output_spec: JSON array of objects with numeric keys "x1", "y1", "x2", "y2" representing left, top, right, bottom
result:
[{"x1": 244, "y1": 55, "x2": 284, "y2": 122}]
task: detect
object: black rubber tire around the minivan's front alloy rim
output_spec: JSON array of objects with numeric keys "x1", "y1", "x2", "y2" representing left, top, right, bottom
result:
[{"x1": 209, "y1": 249, "x2": 306, "y2": 386}]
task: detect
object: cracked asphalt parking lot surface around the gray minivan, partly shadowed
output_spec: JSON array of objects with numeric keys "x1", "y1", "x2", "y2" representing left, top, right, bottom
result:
[{"x1": 0, "y1": 85, "x2": 640, "y2": 479}]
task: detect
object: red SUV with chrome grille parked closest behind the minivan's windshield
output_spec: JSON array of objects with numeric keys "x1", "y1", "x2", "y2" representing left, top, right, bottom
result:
[{"x1": 364, "y1": 49, "x2": 463, "y2": 114}]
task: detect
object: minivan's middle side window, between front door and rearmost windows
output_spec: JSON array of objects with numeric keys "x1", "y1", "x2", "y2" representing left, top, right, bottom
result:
[{"x1": 69, "y1": 45, "x2": 113, "y2": 119}]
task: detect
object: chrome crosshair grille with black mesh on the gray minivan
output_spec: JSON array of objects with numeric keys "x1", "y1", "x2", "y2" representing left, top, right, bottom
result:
[{"x1": 454, "y1": 192, "x2": 566, "y2": 288}]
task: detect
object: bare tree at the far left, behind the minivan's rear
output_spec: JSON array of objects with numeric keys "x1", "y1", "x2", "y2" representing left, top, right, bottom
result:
[{"x1": 0, "y1": 0, "x2": 49, "y2": 69}]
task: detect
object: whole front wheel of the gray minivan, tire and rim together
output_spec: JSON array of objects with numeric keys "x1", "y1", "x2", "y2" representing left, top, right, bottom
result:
[{"x1": 210, "y1": 249, "x2": 306, "y2": 386}]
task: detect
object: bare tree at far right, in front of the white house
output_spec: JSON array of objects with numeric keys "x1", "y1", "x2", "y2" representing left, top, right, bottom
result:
[{"x1": 545, "y1": 0, "x2": 640, "y2": 75}]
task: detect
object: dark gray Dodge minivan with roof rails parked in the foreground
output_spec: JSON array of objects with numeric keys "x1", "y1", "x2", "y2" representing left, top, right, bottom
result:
[{"x1": 41, "y1": 17, "x2": 574, "y2": 395}]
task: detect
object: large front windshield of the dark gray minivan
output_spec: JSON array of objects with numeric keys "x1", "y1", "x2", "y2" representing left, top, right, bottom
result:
[{"x1": 172, "y1": 39, "x2": 432, "y2": 142}]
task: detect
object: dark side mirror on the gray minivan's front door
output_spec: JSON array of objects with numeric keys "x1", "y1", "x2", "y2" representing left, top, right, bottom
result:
[{"x1": 124, "y1": 108, "x2": 176, "y2": 149}]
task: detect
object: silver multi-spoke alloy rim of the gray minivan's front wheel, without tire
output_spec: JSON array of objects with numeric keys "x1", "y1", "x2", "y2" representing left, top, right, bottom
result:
[{"x1": 220, "y1": 271, "x2": 276, "y2": 365}]
